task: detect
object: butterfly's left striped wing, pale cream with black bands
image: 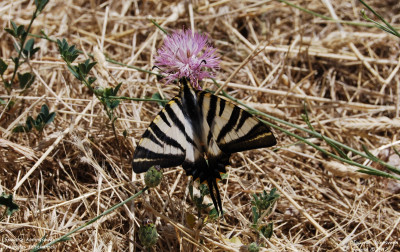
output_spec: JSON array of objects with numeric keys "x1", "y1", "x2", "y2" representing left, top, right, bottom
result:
[{"x1": 132, "y1": 96, "x2": 192, "y2": 173}]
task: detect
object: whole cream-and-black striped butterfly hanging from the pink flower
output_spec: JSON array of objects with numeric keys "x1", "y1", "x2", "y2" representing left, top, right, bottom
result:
[{"x1": 132, "y1": 78, "x2": 276, "y2": 213}]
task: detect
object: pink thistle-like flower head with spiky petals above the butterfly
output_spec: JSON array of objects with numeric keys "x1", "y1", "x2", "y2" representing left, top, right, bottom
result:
[{"x1": 155, "y1": 30, "x2": 220, "y2": 89}]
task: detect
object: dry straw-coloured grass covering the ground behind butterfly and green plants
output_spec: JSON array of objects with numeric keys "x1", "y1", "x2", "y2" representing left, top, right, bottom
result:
[{"x1": 0, "y1": 0, "x2": 400, "y2": 251}]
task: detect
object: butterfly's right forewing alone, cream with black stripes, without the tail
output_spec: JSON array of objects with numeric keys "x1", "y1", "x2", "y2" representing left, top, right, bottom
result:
[{"x1": 198, "y1": 91, "x2": 276, "y2": 153}]
